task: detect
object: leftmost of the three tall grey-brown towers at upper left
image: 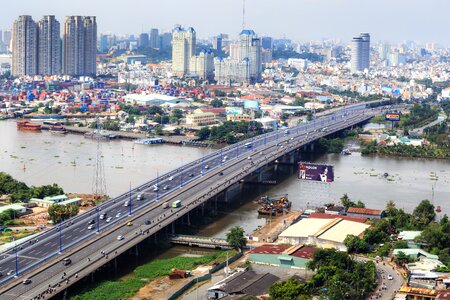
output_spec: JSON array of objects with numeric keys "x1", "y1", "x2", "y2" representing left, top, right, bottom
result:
[{"x1": 12, "y1": 16, "x2": 38, "y2": 76}]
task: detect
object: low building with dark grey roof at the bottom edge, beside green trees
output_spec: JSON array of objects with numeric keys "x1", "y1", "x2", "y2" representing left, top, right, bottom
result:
[{"x1": 208, "y1": 271, "x2": 280, "y2": 299}]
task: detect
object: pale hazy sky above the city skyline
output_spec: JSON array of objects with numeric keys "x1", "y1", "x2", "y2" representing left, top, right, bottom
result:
[{"x1": 0, "y1": 0, "x2": 450, "y2": 46}]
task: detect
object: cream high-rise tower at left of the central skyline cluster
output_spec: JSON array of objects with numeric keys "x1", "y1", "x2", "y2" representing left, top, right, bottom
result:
[{"x1": 172, "y1": 26, "x2": 196, "y2": 77}]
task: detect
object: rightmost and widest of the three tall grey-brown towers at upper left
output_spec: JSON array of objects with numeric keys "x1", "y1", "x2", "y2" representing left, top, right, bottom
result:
[{"x1": 62, "y1": 16, "x2": 97, "y2": 76}]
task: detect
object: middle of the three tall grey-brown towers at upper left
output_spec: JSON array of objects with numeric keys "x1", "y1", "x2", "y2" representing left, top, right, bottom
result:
[{"x1": 38, "y1": 16, "x2": 61, "y2": 75}]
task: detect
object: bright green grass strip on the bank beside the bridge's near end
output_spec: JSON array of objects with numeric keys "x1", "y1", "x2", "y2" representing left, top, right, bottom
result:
[{"x1": 71, "y1": 250, "x2": 237, "y2": 300}]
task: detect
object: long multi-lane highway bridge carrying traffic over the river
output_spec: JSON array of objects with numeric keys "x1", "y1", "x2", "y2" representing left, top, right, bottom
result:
[{"x1": 0, "y1": 104, "x2": 374, "y2": 300}]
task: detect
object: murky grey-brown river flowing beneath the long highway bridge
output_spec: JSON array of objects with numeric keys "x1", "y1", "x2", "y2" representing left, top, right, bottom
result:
[{"x1": 0, "y1": 120, "x2": 450, "y2": 232}]
